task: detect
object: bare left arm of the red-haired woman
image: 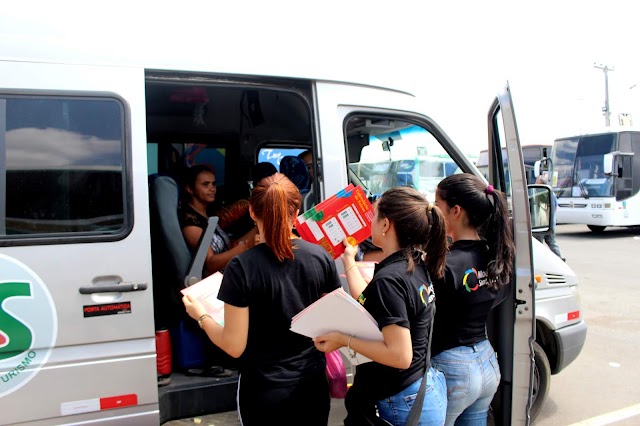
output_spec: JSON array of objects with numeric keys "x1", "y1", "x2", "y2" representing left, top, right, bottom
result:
[{"x1": 182, "y1": 296, "x2": 249, "y2": 358}]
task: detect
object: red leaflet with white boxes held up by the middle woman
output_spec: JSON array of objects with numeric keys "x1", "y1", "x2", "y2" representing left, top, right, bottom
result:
[{"x1": 295, "y1": 184, "x2": 373, "y2": 259}]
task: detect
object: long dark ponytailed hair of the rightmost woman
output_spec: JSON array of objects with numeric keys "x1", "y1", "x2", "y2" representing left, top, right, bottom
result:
[{"x1": 437, "y1": 173, "x2": 515, "y2": 288}]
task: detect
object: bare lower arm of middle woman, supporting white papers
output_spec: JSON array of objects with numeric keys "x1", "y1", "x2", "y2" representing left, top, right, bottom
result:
[{"x1": 313, "y1": 324, "x2": 413, "y2": 369}]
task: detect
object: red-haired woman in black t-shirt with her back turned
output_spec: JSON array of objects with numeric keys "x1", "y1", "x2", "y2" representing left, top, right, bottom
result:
[{"x1": 183, "y1": 173, "x2": 340, "y2": 426}]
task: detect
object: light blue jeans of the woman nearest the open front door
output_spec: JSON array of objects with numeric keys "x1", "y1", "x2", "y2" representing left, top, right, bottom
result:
[{"x1": 431, "y1": 339, "x2": 500, "y2": 426}]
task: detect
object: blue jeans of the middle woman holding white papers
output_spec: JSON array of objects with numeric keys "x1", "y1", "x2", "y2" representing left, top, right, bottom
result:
[{"x1": 378, "y1": 367, "x2": 447, "y2": 426}]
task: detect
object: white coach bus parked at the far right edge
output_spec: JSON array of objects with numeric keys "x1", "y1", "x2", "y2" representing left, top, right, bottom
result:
[{"x1": 551, "y1": 128, "x2": 640, "y2": 232}]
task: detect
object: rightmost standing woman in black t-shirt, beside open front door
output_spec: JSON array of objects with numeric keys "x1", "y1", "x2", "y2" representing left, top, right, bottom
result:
[{"x1": 432, "y1": 174, "x2": 515, "y2": 425}]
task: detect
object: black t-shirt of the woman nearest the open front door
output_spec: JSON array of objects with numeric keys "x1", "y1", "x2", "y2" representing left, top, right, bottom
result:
[{"x1": 432, "y1": 240, "x2": 498, "y2": 355}]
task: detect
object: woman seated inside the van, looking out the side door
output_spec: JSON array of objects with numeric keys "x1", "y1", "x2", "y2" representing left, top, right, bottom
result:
[{"x1": 178, "y1": 164, "x2": 257, "y2": 275}]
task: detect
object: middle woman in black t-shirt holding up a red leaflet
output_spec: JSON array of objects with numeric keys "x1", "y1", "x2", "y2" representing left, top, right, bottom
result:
[{"x1": 314, "y1": 187, "x2": 447, "y2": 425}]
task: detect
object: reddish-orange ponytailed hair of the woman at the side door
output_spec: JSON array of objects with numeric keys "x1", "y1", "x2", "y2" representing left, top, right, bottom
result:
[{"x1": 249, "y1": 173, "x2": 302, "y2": 262}]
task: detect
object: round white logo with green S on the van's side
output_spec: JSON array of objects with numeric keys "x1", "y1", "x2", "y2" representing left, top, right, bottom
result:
[{"x1": 0, "y1": 254, "x2": 58, "y2": 397}]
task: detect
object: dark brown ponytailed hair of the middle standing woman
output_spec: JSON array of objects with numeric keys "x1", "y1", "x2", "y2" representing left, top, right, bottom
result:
[{"x1": 377, "y1": 186, "x2": 447, "y2": 278}]
